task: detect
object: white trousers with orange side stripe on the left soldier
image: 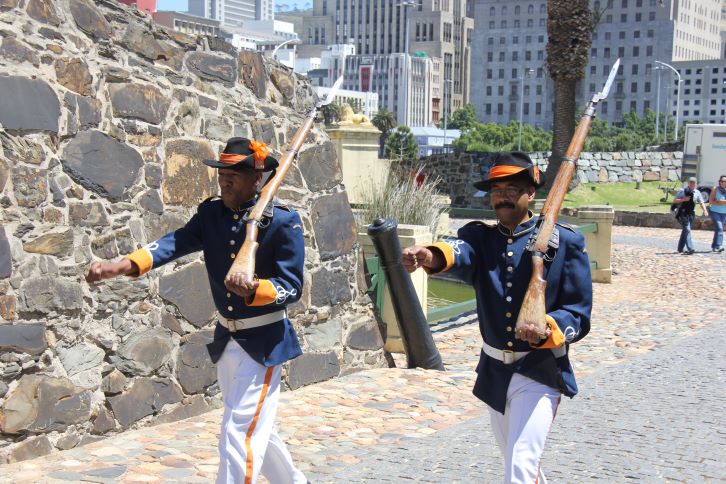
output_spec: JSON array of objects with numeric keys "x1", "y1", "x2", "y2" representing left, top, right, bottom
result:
[{"x1": 217, "y1": 339, "x2": 307, "y2": 484}]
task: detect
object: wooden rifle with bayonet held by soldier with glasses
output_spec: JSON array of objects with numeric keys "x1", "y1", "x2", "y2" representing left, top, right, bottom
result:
[{"x1": 516, "y1": 59, "x2": 620, "y2": 338}]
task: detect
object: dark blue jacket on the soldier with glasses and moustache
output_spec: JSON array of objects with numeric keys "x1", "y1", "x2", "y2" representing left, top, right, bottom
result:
[{"x1": 432, "y1": 217, "x2": 592, "y2": 413}]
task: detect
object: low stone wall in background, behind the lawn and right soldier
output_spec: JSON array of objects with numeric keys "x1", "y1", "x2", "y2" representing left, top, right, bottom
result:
[{"x1": 419, "y1": 152, "x2": 683, "y2": 208}]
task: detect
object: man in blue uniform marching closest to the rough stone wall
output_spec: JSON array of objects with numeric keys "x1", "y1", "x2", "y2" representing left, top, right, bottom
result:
[{"x1": 86, "y1": 138, "x2": 306, "y2": 484}]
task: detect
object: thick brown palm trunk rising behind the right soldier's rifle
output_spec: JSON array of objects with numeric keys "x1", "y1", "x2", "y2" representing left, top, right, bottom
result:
[{"x1": 546, "y1": 0, "x2": 593, "y2": 189}]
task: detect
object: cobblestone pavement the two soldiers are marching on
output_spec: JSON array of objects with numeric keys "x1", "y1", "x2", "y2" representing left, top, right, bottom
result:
[{"x1": 0, "y1": 227, "x2": 726, "y2": 483}]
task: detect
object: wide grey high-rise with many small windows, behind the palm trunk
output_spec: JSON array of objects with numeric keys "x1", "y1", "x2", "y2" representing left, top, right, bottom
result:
[{"x1": 471, "y1": 0, "x2": 721, "y2": 129}]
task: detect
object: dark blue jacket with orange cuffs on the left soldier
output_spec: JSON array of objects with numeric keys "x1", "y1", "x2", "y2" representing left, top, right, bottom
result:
[{"x1": 128, "y1": 200, "x2": 305, "y2": 366}]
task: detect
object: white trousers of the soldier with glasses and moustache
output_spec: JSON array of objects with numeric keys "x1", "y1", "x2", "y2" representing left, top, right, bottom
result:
[{"x1": 489, "y1": 373, "x2": 560, "y2": 484}]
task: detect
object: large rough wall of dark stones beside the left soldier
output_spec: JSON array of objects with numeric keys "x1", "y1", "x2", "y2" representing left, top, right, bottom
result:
[{"x1": 0, "y1": 0, "x2": 385, "y2": 462}]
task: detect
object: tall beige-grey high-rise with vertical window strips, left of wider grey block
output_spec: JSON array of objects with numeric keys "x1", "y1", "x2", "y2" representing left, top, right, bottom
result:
[{"x1": 301, "y1": 0, "x2": 473, "y2": 124}]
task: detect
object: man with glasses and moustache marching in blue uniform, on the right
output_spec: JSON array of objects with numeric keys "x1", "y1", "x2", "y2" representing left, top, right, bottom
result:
[{"x1": 403, "y1": 152, "x2": 592, "y2": 483}]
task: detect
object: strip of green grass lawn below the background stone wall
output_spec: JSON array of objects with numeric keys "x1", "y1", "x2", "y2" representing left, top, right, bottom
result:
[{"x1": 564, "y1": 182, "x2": 681, "y2": 213}]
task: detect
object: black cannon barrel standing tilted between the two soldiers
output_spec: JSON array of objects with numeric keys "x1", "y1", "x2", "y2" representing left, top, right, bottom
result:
[{"x1": 368, "y1": 219, "x2": 444, "y2": 370}]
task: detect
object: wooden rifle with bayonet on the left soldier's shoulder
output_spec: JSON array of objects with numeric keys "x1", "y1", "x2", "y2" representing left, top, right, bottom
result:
[{"x1": 227, "y1": 76, "x2": 343, "y2": 282}]
